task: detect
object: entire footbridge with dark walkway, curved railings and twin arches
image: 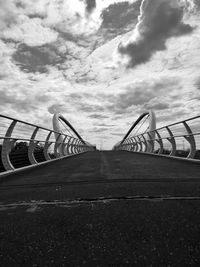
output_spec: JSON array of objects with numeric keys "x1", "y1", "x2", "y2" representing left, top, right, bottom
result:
[{"x1": 0, "y1": 111, "x2": 200, "y2": 266}]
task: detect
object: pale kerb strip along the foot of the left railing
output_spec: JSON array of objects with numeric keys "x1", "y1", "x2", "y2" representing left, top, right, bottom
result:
[{"x1": 0, "y1": 151, "x2": 88, "y2": 182}]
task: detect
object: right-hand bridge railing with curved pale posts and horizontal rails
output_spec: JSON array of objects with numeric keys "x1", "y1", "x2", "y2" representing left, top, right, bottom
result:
[{"x1": 113, "y1": 116, "x2": 200, "y2": 159}]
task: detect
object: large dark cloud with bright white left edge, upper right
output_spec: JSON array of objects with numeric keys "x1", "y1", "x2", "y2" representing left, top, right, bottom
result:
[{"x1": 118, "y1": 0, "x2": 193, "y2": 67}]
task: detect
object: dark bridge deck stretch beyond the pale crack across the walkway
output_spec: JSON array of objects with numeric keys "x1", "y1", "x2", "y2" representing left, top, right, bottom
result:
[{"x1": 0, "y1": 151, "x2": 200, "y2": 201}]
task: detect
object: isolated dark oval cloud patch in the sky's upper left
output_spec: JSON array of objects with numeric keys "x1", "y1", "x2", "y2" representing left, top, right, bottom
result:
[{"x1": 13, "y1": 44, "x2": 66, "y2": 73}]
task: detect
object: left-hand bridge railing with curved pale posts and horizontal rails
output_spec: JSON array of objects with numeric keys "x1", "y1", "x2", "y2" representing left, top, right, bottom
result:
[{"x1": 0, "y1": 115, "x2": 95, "y2": 172}]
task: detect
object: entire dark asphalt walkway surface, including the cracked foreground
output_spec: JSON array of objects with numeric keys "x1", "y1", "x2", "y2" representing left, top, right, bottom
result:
[{"x1": 0, "y1": 151, "x2": 200, "y2": 266}]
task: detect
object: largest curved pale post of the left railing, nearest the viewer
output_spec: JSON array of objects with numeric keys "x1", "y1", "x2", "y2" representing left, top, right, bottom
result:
[{"x1": 1, "y1": 120, "x2": 17, "y2": 171}]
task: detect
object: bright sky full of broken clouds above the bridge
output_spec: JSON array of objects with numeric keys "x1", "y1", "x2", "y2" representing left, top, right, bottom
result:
[{"x1": 0, "y1": 0, "x2": 200, "y2": 148}]
